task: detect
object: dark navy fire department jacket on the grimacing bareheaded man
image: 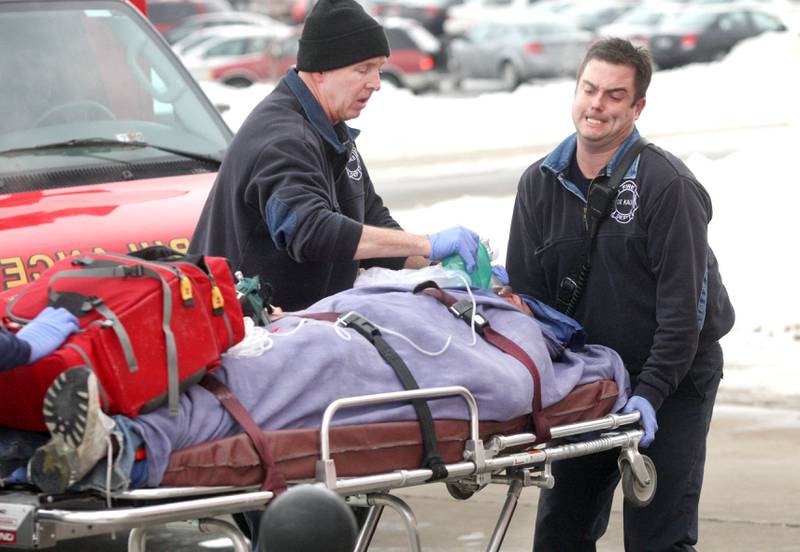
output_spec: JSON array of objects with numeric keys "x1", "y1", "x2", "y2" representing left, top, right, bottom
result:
[{"x1": 506, "y1": 131, "x2": 734, "y2": 408}]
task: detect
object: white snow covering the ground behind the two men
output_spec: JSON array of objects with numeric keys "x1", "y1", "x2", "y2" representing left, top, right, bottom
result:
[{"x1": 203, "y1": 33, "x2": 800, "y2": 405}]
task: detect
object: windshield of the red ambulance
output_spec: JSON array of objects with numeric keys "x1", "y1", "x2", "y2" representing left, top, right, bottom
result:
[{"x1": 0, "y1": 1, "x2": 231, "y2": 176}]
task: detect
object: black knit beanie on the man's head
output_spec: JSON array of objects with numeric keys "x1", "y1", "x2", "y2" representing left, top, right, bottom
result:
[{"x1": 297, "y1": 0, "x2": 389, "y2": 72}]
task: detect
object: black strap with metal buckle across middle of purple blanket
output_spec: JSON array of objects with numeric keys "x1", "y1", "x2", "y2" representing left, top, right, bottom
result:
[{"x1": 302, "y1": 312, "x2": 448, "y2": 481}]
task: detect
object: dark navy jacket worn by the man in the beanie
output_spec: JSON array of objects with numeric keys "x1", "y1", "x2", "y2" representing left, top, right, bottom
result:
[{"x1": 189, "y1": 70, "x2": 405, "y2": 310}]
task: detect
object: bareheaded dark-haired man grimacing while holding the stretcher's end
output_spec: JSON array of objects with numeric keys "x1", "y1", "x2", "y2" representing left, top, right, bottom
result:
[{"x1": 506, "y1": 38, "x2": 734, "y2": 552}]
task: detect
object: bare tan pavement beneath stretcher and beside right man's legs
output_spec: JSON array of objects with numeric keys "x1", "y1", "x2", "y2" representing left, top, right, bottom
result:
[{"x1": 370, "y1": 405, "x2": 800, "y2": 552}]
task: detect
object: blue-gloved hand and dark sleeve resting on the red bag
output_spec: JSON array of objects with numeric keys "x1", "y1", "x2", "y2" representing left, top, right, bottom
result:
[{"x1": 0, "y1": 307, "x2": 78, "y2": 372}]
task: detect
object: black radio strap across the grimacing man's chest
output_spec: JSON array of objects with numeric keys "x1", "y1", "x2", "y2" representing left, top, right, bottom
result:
[{"x1": 556, "y1": 136, "x2": 650, "y2": 316}]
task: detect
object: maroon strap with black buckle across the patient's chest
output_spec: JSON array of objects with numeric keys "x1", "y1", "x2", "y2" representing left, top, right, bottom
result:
[{"x1": 414, "y1": 280, "x2": 551, "y2": 443}]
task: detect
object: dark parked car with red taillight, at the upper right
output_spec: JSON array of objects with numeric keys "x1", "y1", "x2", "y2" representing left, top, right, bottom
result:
[{"x1": 650, "y1": 5, "x2": 786, "y2": 68}]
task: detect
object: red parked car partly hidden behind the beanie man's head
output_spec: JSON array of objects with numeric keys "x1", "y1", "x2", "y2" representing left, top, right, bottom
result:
[{"x1": 241, "y1": 17, "x2": 441, "y2": 93}]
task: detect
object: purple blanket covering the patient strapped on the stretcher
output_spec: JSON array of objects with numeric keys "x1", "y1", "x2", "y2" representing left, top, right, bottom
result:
[{"x1": 135, "y1": 286, "x2": 628, "y2": 486}]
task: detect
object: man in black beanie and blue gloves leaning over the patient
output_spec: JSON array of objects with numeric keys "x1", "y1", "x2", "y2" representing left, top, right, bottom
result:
[{"x1": 189, "y1": 0, "x2": 479, "y2": 310}]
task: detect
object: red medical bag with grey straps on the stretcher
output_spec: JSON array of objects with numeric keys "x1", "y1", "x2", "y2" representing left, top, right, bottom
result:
[{"x1": 0, "y1": 248, "x2": 244, "y2": 430}]
